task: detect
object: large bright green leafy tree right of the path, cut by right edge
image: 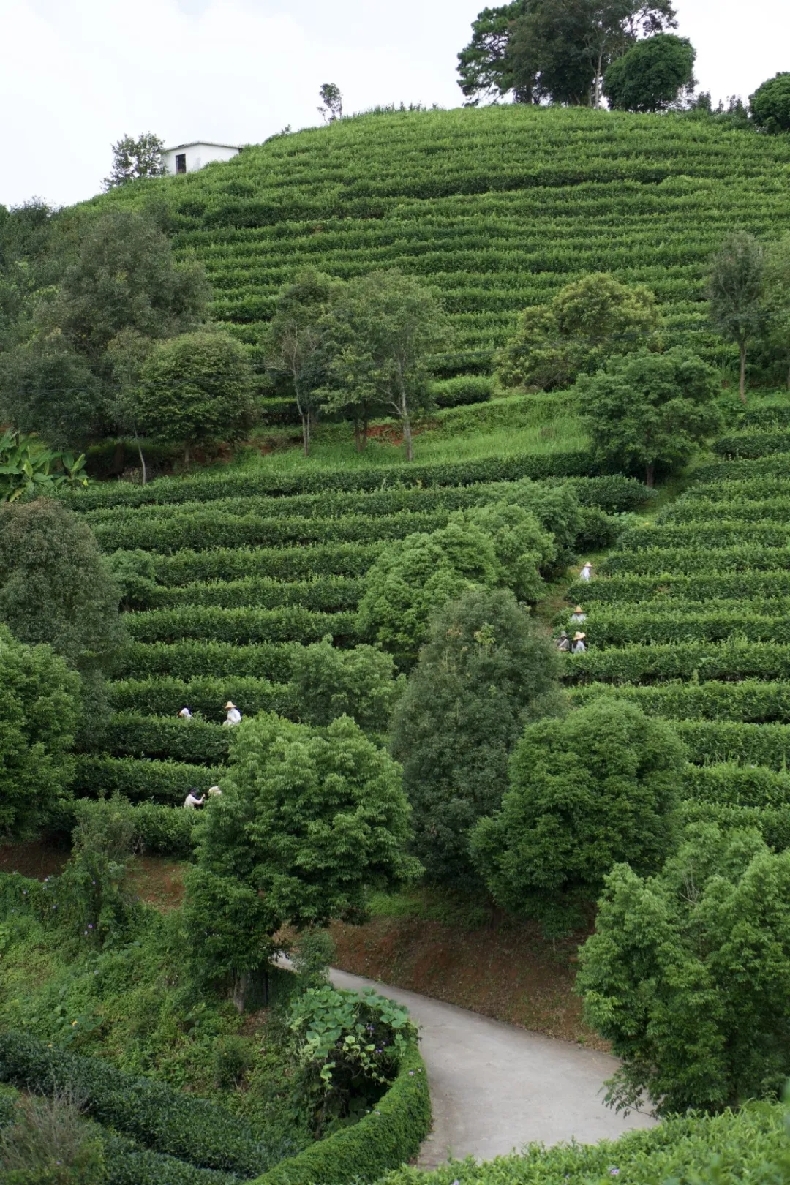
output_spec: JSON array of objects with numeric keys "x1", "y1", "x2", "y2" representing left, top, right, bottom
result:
[{"x1": 578, "y1": 825, "x2": 790, "y2": 1115}]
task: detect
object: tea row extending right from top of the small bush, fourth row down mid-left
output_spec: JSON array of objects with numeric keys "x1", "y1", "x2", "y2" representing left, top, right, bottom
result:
[{"x1": 153, "y1": 543, "x2": 384, "y2": 585}]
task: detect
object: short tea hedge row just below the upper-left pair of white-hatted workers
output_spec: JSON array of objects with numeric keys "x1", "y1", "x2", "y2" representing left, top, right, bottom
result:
[{"x1": 102, "y1": 712, "x2": 231, "y2": 768}]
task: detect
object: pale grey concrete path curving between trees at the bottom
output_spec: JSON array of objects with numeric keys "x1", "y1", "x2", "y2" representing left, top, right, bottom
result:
[{"x1": 332, "y1": 971, "x2": 654, "y2": 1168}]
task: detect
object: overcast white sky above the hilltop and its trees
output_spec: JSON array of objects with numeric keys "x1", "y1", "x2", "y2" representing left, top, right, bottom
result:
[{"x1": 0, "y1": 0, "x2": 790, "y2": 205}]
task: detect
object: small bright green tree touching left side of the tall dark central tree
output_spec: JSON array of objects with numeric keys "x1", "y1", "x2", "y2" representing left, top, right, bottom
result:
[{"x1": 290, "y1": 638, "x2": 403, "y2": 734}]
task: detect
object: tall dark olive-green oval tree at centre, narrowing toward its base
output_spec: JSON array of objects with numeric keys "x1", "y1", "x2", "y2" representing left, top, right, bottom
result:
[{"x1": 392, "y1": 588, "x2": 560, "y2": 885}]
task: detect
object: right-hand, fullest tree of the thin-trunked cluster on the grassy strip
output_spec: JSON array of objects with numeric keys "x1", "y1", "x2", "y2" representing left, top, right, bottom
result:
[{"x1": 323, "y1": 271, "x2": 449, "y2": 461}]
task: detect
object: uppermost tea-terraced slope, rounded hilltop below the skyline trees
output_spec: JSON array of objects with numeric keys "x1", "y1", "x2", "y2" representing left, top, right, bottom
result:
[{"x1": 95, "y1": 105, "x2": 790, "y2": 373}]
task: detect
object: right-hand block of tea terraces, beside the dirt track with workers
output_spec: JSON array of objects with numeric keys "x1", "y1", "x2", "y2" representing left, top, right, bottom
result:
[{"x1": 567, "y1": 409, "x2": 790, "y2": 850}]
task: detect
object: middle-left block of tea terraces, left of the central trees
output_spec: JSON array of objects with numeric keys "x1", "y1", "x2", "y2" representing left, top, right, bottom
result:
[{"x1": 64, "y1": 453, "x2": 647, "y2": 803}]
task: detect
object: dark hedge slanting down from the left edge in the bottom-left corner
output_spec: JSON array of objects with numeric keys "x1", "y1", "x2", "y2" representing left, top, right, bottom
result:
[{"x1": 0, "y1": 1032, "x2": 280, "y2": 1178}]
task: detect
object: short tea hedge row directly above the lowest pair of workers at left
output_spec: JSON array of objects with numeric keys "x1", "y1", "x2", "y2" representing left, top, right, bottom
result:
[{"x1": 72, "y1": 754, "x2": 227, "y2": 810}]
